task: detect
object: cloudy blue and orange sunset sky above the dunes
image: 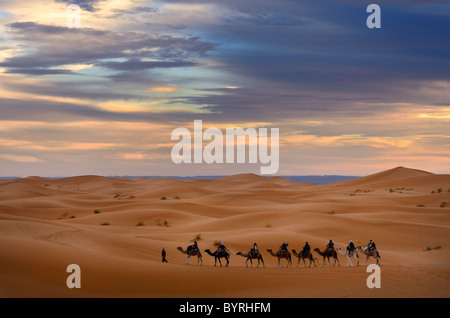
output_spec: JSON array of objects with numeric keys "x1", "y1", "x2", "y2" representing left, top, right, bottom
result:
[{"x1": 0, "y1": 0, "x2": 450, "y2": 177}]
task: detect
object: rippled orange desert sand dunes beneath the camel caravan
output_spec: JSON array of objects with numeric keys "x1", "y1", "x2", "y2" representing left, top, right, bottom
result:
[{"x1": 0, "y1": 167, "x2": 450, "y2": 297}]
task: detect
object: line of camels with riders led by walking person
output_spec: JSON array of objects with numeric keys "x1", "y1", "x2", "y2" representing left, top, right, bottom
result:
[{"x1": 174, "y1": 240, "x2": 381, "y2": 267}]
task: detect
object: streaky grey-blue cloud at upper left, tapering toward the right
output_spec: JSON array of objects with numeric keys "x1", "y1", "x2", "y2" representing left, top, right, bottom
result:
[{"x1": 0, "y1": 22, "x2": 216, "y2": 74}]
